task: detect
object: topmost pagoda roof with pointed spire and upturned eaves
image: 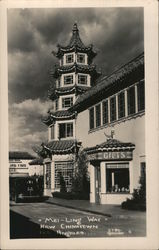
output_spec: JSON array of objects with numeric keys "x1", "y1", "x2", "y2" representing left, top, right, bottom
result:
[{"x1": 52, "y1": 23, "x2": 97, "y2": 61}]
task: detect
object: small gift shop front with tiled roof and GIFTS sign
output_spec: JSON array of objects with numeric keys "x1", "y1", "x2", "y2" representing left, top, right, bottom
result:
[{"x1": 86, "y1": 139, "x2": 135, "y2": 204}]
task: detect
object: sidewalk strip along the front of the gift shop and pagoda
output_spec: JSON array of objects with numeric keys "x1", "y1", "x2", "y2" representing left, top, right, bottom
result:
[{"x1": 45, "y1": 197, "x2": 145, "y2": 218}]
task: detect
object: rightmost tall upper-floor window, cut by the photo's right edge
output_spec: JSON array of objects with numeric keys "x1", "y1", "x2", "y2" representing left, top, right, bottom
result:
[{"x1": 137, "y1": 81, "x2": 145, "y2": 111}]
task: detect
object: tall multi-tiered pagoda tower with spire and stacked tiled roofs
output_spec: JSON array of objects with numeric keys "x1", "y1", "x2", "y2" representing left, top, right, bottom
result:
[{"x1": 38, "y1": 23, "x2": 100, "y2": 195}]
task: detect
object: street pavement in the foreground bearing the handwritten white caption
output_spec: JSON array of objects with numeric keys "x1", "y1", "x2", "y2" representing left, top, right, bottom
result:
[{"x1": 10, "y1": 202, "x2": 146, "y2": 238}]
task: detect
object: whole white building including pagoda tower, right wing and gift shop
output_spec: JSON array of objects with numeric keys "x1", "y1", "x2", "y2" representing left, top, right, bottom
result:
[{"x1": 37, "y1": 24, "x2": 146, "y2": 204}]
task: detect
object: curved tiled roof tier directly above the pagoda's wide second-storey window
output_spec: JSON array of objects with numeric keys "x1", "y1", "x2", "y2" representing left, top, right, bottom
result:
[{"x1": 42, "y1": 109, "x2": 76, "y2": 126}]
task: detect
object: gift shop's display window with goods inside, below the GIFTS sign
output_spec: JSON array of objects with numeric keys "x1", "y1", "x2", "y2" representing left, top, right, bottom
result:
[{"x1": 106, "y1": 163, "x2": 130, "y2": 193}]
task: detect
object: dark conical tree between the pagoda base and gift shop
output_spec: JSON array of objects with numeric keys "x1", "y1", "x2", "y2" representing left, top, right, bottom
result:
[{"x1": 72, "y1": 150, "x2": 90, "y2": 194}]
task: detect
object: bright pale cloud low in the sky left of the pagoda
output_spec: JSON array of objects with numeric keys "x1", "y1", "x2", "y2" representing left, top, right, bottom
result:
[{"x1": 9, "y1": 99, "x2": 52, "y2": 152}]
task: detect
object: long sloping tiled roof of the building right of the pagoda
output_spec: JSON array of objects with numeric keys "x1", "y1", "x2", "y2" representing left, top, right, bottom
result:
[{"x1": 70, "y1": 52, "x2": 144, "y2": 112}]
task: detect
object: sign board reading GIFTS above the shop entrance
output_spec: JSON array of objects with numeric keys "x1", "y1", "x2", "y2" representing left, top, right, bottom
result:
[{"x1": 88, "y1": 151, "x2": 132, "y2": 160}]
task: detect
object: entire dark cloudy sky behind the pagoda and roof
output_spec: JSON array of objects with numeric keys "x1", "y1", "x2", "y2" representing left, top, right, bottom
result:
[{"x1": 8, "y1": 7, "x2": 144, "y2": 153}]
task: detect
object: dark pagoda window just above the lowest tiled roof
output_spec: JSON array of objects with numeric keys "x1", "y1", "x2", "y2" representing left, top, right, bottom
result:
[{"x1": 59, "y1": 123, "x2": 73, "y2": 138}]
